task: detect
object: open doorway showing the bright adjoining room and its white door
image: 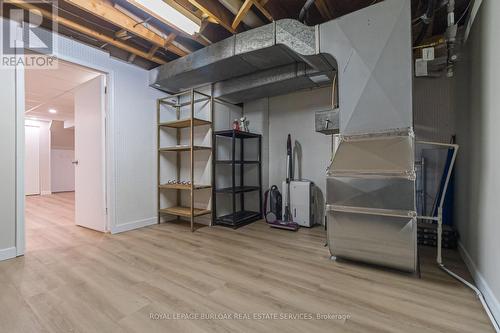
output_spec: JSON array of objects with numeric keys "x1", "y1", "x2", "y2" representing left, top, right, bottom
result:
[{"x1": 24, "y1": 61, "x2": 108, "y2": 252}]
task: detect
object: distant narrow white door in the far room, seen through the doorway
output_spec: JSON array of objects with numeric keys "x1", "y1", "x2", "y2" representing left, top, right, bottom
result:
[{"x1": 24, "y1": 126, "x2": 40, "y2": 195}]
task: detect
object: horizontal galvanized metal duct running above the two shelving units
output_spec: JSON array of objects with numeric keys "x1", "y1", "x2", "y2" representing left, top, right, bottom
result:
[{"x1": 150, "y1": 19, "x2": 337, "y2": 103}]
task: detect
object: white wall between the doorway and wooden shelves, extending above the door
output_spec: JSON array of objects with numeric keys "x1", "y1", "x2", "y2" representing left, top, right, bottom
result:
[{"x1": 45, "y1": 29, "x2": 163, "y2": 232}]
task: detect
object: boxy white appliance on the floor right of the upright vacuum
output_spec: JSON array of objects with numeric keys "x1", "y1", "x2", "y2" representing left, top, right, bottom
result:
[{"x1": 281, "y1": 180, "x2": 316, "y2": 227}]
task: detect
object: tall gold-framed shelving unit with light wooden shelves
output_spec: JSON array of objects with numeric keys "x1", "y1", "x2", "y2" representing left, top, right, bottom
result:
[{"x1": 157, "y1": 89, "x2": 214, "y2": 231}]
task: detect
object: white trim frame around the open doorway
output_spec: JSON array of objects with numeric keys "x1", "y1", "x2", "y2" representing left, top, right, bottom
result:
[{"x1": 16, "y1": 54, "x2": 116, "y2": 256}]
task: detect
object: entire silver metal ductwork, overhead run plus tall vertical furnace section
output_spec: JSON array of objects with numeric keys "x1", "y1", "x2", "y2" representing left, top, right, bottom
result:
[{"x1": 150, "y1": 0, "x2": 417, "y2": 271}]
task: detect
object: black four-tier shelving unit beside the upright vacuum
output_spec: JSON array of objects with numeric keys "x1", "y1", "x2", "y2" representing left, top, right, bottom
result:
[{"x1": 212, "y1": 130, "x2": 263, "y2": 228}]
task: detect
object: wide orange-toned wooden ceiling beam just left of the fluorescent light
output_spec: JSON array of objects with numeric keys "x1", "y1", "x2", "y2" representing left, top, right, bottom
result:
[{"x1": 64, "y1": 0, "x2": 187, "y2": 57}]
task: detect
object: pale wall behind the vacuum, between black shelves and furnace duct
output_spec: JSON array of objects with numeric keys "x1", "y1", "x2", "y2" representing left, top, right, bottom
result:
[{"x1": 244, "y1": 87, "x2": 331, "y2": 195}]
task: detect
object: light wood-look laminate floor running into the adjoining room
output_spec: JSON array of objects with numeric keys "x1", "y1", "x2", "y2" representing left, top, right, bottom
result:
[{"x1": 0, "y1": 193, "x2": 493, "y2": 333}]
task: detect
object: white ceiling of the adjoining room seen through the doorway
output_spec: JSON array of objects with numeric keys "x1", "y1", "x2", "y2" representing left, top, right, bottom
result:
[{"x1": 25, "y1": 61, "x2": 101, "y2": 121}]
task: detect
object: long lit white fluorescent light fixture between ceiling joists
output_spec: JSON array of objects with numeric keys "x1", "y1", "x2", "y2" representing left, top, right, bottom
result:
[{"x1": 129, "y1": 0, "x2": 200, "y2": 35}]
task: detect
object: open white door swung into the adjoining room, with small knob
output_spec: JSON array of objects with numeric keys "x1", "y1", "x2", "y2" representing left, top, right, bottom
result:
[{"x1": 74, "y1": 75, "x2": 107, "y2": 231}]
